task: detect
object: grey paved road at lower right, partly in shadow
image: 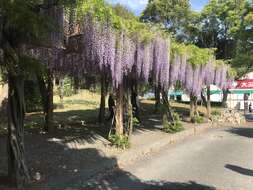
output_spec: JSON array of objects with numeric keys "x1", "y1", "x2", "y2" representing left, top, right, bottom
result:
[{"x1": 84, "y1": 128, "x2": 253, "y2": 190}]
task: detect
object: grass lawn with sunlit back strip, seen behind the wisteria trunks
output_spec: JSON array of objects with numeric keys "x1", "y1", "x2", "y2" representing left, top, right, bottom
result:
[{"x1": 0, "y1": 90, "x2": 222, "y2": 134}]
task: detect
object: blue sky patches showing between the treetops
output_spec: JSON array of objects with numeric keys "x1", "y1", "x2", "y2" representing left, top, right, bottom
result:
[{"x1": 106, "y1": 0, "x2": 208, "y2": 15}]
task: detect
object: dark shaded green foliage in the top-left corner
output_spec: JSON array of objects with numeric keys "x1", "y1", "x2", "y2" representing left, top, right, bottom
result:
[{"x1": 0, "y1": 0, "x2": 54, "y2": 46}]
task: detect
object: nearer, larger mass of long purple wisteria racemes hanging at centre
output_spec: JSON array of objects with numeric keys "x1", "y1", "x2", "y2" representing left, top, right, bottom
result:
[{"x1": 64, "y1": 11, "x2": 174, "y2": 88}]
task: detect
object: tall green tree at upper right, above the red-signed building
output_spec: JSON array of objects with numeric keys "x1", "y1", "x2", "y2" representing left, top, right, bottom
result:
[{"x1": 197, "y1": 0, "x2": 246, "y2": 59}]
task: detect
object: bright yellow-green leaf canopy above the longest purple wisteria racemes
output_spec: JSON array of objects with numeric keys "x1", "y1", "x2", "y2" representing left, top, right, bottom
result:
[{"x1": 77, "y1": 0, "x2": 169, "y2": 44}]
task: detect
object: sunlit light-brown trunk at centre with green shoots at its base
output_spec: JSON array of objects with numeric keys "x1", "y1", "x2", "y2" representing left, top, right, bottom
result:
[{"x1": 115, "y1": 84, "x2": 124, "y2": 136}]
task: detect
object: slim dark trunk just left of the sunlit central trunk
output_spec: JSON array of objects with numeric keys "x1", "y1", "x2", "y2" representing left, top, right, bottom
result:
[{"x1": 98, "y1": 73, "x2": 107, "y2": 123}]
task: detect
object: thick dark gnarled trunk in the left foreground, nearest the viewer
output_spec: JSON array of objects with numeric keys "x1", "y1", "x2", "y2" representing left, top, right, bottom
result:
[{"x1": 2, "y1": 41, "x2": 30, "y2": 189}]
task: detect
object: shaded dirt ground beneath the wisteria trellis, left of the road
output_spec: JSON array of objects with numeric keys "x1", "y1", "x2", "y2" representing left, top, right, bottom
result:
[{"x1": 0, "y1": 91, "x2": 215, "y2": 189}]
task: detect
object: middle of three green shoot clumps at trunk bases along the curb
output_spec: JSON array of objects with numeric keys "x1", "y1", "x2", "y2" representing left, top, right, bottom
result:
[{"x1": 163, "y1": 112, "x2": 184, "y2": 133}]
